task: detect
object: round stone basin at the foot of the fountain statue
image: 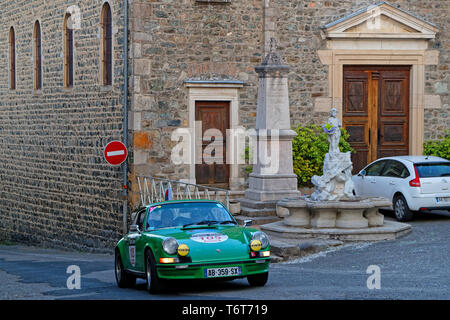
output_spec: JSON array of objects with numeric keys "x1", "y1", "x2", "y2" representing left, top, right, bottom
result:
[{"x1": 261, "y1": 196, "x2": 411, "y2": 241}]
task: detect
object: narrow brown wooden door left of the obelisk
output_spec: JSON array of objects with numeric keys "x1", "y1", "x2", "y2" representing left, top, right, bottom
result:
[{"x1": 195, "y1": 101, "x2": 230, "y2": 188}]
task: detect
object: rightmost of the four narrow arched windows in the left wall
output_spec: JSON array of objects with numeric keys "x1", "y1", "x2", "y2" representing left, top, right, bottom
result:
[{"x1": 100, "y1": 3, "x2": 112, "y2": 86}]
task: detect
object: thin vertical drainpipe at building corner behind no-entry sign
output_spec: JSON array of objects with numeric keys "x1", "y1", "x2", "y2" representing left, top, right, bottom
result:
[{"x1": 122, "y1": 0, "x2": 129, "y2": 234}]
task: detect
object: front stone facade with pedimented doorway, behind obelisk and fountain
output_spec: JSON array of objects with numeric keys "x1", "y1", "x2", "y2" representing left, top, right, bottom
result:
[{"x1": 130, "y1": 0, "x2": 450, "y2": 203}]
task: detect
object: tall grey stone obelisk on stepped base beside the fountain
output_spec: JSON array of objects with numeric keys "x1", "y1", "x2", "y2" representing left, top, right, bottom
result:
[{"x1": 241, "y1": 38, "x2": 300, "y2": 220}]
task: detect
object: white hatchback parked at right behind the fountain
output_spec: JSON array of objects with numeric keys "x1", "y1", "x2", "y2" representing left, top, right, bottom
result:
[{"x1": 352, "y1": 156, "x2": 450, "y2": 221}]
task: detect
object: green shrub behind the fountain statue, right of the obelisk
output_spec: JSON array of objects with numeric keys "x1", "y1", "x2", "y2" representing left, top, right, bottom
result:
[{"x1": 292, "y1": 124, "x2": 355, "y2": 186}]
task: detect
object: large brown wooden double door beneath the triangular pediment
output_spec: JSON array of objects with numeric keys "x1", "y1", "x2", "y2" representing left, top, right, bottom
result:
[{"x1": 342, "y1": 66, "x2": 410, "y2": 173}]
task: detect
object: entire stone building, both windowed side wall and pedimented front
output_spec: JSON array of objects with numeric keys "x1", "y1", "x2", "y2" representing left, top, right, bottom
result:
[{"x1": 0, "y1": 0, "x2": 450, "y2": 249}]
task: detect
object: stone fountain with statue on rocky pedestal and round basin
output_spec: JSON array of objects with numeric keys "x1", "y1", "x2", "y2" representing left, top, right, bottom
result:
[{"x1": 261, "y1": 108, "x2": 411, "y2": 241}]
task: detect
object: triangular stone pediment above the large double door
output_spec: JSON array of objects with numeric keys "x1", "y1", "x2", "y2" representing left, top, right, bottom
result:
[{"x1": 322, "y1": 2, "x2": 438, "y2": 39}]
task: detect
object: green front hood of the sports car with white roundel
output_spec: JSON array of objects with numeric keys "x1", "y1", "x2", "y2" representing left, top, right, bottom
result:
[{"x1": 149, "y1": 226, "x2": 256, "y2": 263}]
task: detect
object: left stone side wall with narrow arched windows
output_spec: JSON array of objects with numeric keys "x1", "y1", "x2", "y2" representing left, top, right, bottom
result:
[{"x1": 0, "y1": 0, "x2": 123, "y2": 251}]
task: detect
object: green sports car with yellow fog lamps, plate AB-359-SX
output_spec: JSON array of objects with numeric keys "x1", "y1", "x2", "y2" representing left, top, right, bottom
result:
[{"x1": 115, "y1": 200, "x2": 270, "y2": 293}]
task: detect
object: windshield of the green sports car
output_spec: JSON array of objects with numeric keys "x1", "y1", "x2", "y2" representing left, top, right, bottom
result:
[{"x1": 146, "y1": 202, "x2": 237, "y2": 230}]
